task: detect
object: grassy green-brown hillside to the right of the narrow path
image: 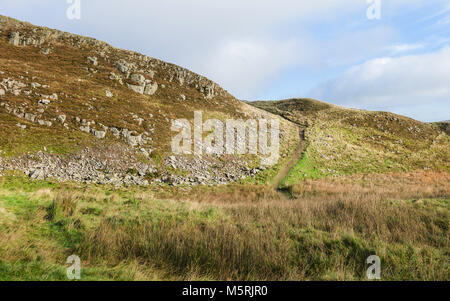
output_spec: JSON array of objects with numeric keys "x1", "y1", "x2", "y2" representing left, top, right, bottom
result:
[{"x1": 251, "y1": 99, "x2": 450, "y2": 186}]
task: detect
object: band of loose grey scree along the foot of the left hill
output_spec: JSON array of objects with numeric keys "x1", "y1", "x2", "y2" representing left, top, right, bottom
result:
[{"x1": 0, "y1": 146, "x2": 264, "y2": 186}]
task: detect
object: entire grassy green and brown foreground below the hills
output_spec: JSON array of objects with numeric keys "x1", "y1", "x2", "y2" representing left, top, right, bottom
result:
[{"x1": 0, "y1": 171, "x2": 450, "y2": 280}]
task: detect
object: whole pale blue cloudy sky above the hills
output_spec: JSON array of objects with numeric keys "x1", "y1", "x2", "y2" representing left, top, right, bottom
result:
[{"x1": 0, "y1": 0, "x2": 450, "y2": 122}]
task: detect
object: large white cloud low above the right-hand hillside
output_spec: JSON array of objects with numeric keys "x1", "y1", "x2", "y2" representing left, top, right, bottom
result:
[{"x1": 311, "y1": 47, "x2": 450, "y2": 120}]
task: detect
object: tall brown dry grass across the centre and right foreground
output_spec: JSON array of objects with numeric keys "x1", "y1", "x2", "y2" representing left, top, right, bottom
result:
[{"x1": 78, "y1": 173, "x2": 449, "y2": 280}]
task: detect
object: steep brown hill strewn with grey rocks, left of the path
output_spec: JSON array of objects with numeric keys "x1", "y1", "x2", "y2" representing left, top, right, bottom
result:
[{"x1": 0, "y1": 16, "x2": 298, "y2": 185}]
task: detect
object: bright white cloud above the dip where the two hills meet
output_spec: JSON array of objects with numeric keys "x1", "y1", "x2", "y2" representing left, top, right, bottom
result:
[{"x1": 198, "y1": 37, "x2": 315, "y2": 99}]
